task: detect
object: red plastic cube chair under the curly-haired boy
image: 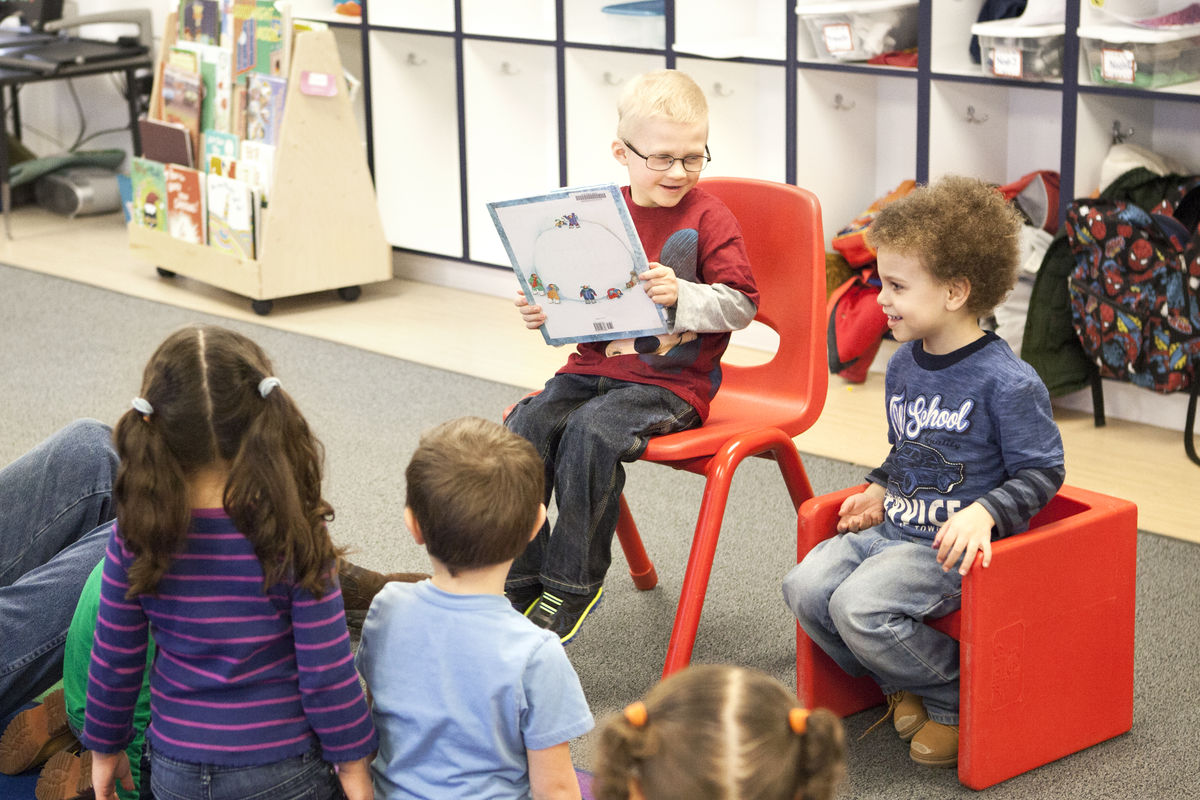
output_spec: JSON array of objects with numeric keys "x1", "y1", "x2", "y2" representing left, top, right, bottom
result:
[{"x1": 796, "y1": 486, "x2": 1138, "y2": 789}]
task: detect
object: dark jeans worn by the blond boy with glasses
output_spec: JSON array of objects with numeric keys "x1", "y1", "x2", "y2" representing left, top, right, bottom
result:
[{"x1": 505, "y1": 374, "x2": 700, "y2": 595}]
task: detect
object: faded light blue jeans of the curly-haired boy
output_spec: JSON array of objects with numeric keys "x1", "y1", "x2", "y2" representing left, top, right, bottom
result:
[{"x1": 784, "y1": 525, "x2": 962, "y2": 724}]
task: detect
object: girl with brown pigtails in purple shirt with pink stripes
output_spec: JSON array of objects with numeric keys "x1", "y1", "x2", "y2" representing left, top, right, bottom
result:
[{"x1": 82, "y1": 326, "x2": 377, "y2": 800}]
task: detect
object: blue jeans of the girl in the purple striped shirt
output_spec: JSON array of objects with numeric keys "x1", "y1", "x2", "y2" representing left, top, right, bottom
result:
[{"x1": 150, "y1": 748, "x2": 346, "y2": 800}]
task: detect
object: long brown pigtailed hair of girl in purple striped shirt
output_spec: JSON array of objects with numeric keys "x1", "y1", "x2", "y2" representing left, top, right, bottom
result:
[{"x1": 113, "y1": 325, "x2": 341, "y2": 597}]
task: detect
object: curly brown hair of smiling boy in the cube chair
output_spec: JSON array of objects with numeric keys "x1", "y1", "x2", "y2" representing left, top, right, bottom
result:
[{"x1": 866, "y1": 175, "x2": 1021, "y2": 317}]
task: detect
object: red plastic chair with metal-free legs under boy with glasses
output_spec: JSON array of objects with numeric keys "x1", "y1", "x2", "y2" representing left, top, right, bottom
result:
[{"x1": 617, "y1": 178, "x2": 828, "y2": 676}]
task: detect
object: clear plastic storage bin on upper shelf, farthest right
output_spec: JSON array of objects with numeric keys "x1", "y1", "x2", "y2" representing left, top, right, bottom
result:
[{"x1": 1079, "y1": 25, "x2": 1200, "y2": 89}]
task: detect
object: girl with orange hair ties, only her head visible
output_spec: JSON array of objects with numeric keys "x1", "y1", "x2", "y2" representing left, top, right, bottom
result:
[{"x1": 593, "y1": 664, "x2": 845, "y2": 800}]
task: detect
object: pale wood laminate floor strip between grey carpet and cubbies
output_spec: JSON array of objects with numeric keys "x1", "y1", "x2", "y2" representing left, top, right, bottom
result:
[{"x1": 0, "y1": 209, "x2": 1200, "y2": 542}]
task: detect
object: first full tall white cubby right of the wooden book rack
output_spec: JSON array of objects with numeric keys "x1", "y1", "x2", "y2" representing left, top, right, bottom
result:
[{"x1": 370, "y1": 31, "x2": 464, "y2": 258}]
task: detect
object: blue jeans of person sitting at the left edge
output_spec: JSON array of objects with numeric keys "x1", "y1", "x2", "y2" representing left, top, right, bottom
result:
[{"x1": 0, "y1": 420, "x2": 116, "y2": 716}]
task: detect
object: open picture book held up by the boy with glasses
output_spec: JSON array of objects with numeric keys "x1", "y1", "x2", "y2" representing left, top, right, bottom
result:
[{"x1": 487, "y1": 184, "x2": 667, "y2": 344}]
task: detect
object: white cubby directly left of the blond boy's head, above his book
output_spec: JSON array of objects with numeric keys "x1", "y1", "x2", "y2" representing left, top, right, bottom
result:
[{"x1": 565, "y1": 48, "x2": 664, "y2": 186}]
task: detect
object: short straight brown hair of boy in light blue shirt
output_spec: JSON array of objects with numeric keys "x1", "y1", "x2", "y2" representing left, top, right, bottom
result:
[{"x1": 404, "y1": 416, "x2": 546, "y2": 575}]
